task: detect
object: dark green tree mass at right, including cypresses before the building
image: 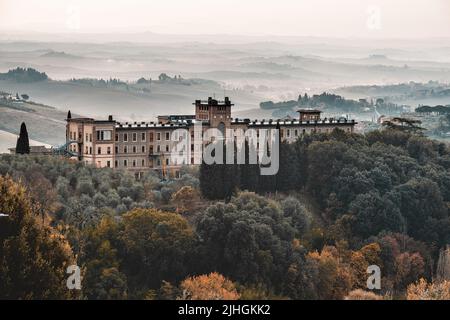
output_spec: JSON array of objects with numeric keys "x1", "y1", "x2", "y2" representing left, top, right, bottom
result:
[{"x1": 200, "y1": 129, "x2": 450, "y2": 266}]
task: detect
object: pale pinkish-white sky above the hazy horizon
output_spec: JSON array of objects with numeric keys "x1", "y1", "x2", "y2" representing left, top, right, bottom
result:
[{"x1": 0, "y1": 0, "x2": 450, "y2": 38}]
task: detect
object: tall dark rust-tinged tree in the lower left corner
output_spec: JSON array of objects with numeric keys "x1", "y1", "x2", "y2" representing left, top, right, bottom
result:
[{"x1": 0, "y1": 176, "x2": 74, "y2": 299}]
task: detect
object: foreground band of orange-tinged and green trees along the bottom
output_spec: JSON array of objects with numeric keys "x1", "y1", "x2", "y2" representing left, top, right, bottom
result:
[{"x1": 0, "y1": 172, "x2": 449, "y2": 299}]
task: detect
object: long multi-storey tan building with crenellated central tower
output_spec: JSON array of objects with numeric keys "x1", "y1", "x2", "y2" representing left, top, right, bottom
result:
[{"x1": 66, "y1": 97, "x2": 356, "y2": 178}]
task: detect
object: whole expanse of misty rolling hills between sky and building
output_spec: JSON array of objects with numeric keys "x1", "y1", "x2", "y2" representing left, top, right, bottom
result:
[{"x1": 0, "y1": 32, "x2": 450, "y2": 148}]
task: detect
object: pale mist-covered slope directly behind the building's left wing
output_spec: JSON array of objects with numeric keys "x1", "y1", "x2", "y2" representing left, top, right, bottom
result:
[{"x1": 0, "y1": 75, "x2": 260, "y2": 121}]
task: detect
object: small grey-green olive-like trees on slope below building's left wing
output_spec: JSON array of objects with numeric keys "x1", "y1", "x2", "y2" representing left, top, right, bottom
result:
[{"x1": 0, "y1": 155, "x2": 199, "y2": 228}]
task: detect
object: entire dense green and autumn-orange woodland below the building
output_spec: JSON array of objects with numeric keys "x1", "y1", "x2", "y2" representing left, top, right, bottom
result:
[{"x1": 0, "y1": 129, "x2": 450, "y2": 299}]
